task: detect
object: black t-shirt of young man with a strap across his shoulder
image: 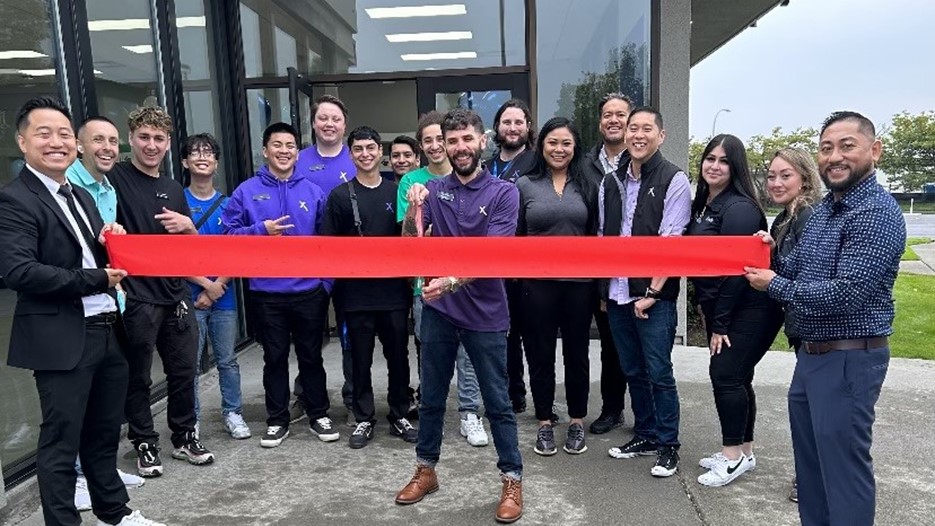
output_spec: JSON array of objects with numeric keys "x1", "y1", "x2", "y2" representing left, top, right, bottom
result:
[{"x1": 321, "y1": 178, "x2": 411, "y2": 311}]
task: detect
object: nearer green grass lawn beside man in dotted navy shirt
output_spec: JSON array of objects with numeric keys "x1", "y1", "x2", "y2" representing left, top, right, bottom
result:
[{"x1": 764, "y1": 274, "x2": 935, "y2": 360}]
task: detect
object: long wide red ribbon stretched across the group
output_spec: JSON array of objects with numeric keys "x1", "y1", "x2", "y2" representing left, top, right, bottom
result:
[{"x1": 107, "y1": 235, "x2": 769, "y2": 278}]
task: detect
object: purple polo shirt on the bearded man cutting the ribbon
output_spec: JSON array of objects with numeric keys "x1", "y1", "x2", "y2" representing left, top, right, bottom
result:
[{"x1": 423, "y1": 170, "x2": 519, "y2": 332}]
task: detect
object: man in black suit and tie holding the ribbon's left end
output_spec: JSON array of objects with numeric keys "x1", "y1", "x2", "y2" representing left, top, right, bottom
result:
[{"x1": 0, "y1": 97, "x2": 164, "y2": 526}]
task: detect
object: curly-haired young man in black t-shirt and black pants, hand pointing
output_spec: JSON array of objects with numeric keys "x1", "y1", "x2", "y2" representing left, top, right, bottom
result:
[{"x1": 108, "y1": 106, "x2": 214, "y2": 477}]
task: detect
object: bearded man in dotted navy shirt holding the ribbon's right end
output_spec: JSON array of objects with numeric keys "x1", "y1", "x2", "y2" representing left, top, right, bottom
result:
[{"x1": 746, "y1": 111, "x2": 906, "y2": 526}]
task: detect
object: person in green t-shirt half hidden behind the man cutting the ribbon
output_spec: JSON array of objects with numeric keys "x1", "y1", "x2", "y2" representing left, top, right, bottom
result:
[{"x1": 396, "y1": 111, "x2": 489, "y2": 447}]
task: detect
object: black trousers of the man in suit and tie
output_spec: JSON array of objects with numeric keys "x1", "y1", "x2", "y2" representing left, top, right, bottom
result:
[{"x1": 34, "y1": 325, "x2": 130, "y2": 526}]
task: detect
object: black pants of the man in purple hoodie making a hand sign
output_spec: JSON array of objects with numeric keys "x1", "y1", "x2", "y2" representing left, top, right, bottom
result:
[{"x1": 250, "y1": 286, "x2": 330, "y2": 427}]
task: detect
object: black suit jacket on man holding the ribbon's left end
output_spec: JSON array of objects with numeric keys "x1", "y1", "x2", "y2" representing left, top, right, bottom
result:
[{"x1": 0, "y1": 167, "x2": 108, "y2": 371}]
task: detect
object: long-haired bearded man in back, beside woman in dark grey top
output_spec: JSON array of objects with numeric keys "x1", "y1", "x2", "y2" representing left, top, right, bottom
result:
[{"x1": 488, "y1": 99, "x2": 536, "y2": 413}]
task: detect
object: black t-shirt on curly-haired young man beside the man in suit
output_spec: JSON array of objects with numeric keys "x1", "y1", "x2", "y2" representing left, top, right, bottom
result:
[{"x1": 107, "y1": 161, "x2": 191, "y2": 305}]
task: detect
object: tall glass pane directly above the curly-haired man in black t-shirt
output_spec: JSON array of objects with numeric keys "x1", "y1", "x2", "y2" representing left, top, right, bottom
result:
[{"x1": 87, "y1": 0, "x2": 164, "y2": 143}]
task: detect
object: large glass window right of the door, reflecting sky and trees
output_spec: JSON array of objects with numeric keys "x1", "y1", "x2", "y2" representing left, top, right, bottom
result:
[{"x1": 536, "y1": 0, "x2": 650, "y2": 148}]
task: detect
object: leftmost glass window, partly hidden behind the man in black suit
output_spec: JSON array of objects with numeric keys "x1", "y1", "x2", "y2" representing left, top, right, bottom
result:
[{"x1": 0, "y1": 0, "x2": 64, "y2": 480}]
